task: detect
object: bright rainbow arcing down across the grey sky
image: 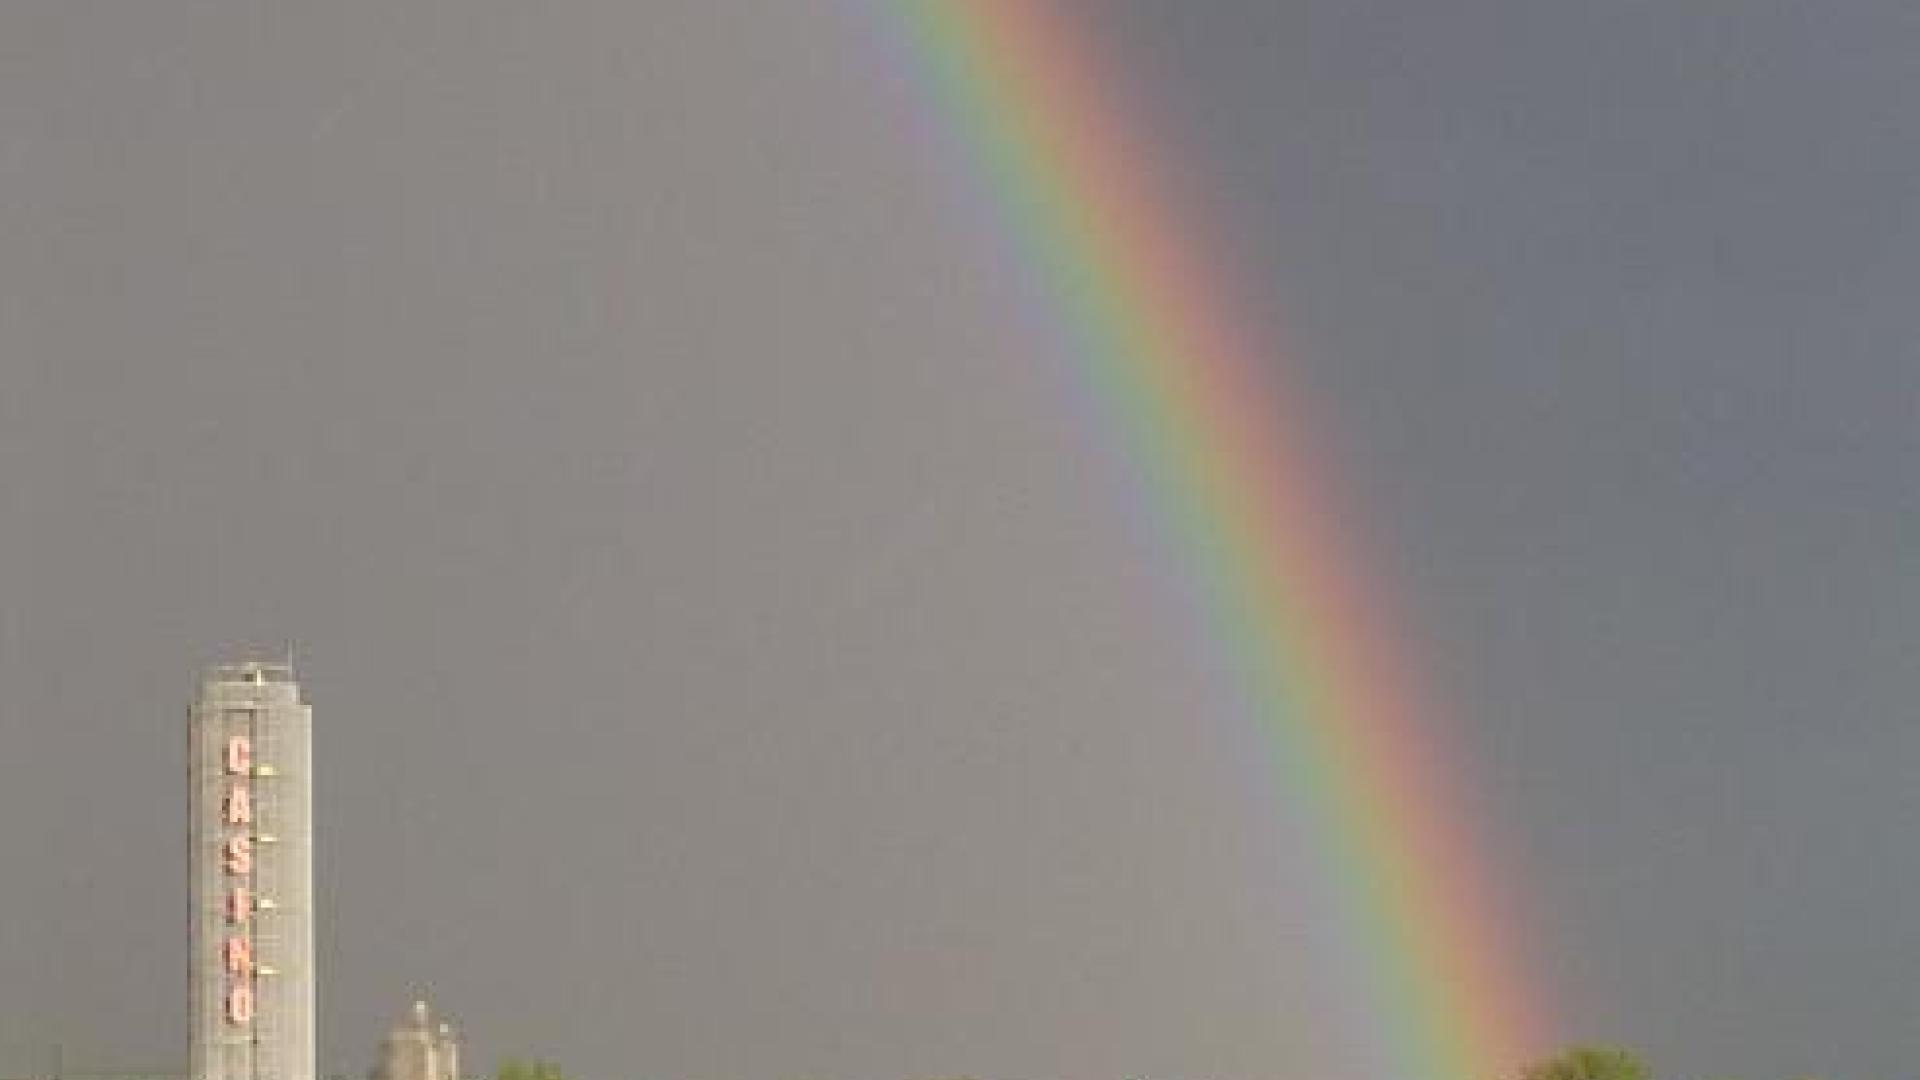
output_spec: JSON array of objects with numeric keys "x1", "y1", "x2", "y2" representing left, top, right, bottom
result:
[{"x1": 877, "y1": 0, "x2": 1549, "y2": 1080}]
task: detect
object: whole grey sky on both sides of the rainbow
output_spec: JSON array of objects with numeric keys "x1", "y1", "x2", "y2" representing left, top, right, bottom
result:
[{"x1": 0, "y1": 0, "x2": 1920, "y2": 1080}]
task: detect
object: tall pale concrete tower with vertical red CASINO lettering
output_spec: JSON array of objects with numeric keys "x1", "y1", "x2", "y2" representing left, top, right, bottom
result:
[{"x1": 186, "y1": 663, "x2": 315, "y2": 1080}]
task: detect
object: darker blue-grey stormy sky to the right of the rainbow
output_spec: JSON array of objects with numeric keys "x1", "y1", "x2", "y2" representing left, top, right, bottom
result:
[{"x1": 1119, "y1": 2, "x2": 1920, "y2": 1078}]
